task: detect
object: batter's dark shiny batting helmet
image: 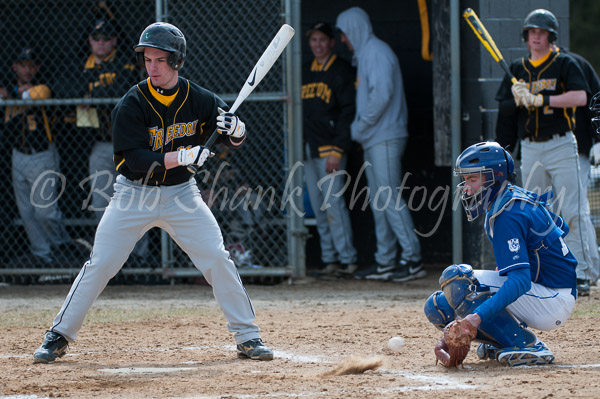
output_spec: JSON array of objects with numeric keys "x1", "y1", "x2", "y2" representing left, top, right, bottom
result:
[{"x1": 133, "y1": 22, "x2": 186, "y2": 70}]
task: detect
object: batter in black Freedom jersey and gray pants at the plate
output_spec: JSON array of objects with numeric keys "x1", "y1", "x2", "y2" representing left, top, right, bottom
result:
[{"x1": 34, "y1": 22, "x2": 273, "y2": 363}]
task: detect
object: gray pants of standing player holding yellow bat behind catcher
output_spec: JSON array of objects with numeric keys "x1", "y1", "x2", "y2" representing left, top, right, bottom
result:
[{"x1": 521, "y1": 132, "x2": 598, "y2": 280}]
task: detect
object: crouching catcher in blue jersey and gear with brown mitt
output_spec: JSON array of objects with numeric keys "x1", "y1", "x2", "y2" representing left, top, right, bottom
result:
[{"x1": 425, "y1": 142, "x2": 577, "y2": 367}]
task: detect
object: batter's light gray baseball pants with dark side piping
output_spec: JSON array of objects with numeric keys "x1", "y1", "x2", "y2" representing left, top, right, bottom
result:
[{"x1": 50, "y1": 175, "x2": 260, "y2": 344}]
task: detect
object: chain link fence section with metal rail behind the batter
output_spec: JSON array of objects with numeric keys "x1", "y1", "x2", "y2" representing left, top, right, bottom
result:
[{"x1": 0, "y1": 0, "x2": 291, "y2": 283}]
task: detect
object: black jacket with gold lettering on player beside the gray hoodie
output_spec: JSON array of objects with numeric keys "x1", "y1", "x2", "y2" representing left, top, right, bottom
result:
[{"x1": 302, "y1": 54, "x2": 356, "y2": 158}]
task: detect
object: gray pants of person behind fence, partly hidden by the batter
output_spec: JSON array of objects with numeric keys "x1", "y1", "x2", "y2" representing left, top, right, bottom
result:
[{"x1": 89, "y1": 141, "x2": 150, "y2": 258}]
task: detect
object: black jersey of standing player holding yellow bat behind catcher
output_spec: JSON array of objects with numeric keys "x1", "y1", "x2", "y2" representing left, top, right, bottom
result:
[{"x1": 496, "y1": 51, "x2": 590, "y2": 140}]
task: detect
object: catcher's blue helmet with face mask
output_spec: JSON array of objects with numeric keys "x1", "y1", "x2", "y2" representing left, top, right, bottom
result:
[{"x1": 454, "y1": 141, "x2": 515, "y2": 221}]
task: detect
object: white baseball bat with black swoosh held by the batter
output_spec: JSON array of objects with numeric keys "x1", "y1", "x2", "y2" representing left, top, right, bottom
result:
[{"x1": 187, "y1": 24, "x2": 296, "y2": 174}]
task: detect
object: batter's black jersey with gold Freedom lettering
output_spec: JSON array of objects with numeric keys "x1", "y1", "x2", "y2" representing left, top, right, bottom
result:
[{"x1": 111, "y1": 77, "x2": 237, "y2": 185}]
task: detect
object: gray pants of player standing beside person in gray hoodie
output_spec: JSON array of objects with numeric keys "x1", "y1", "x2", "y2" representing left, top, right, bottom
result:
[{"x1": 304, "y1": 148, "x2": 357, "y2": 264}]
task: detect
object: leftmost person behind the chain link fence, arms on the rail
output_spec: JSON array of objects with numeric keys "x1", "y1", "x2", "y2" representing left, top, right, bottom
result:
[{"x1": 0, "y1": 47, "x2": 75, "y2": 267}]
